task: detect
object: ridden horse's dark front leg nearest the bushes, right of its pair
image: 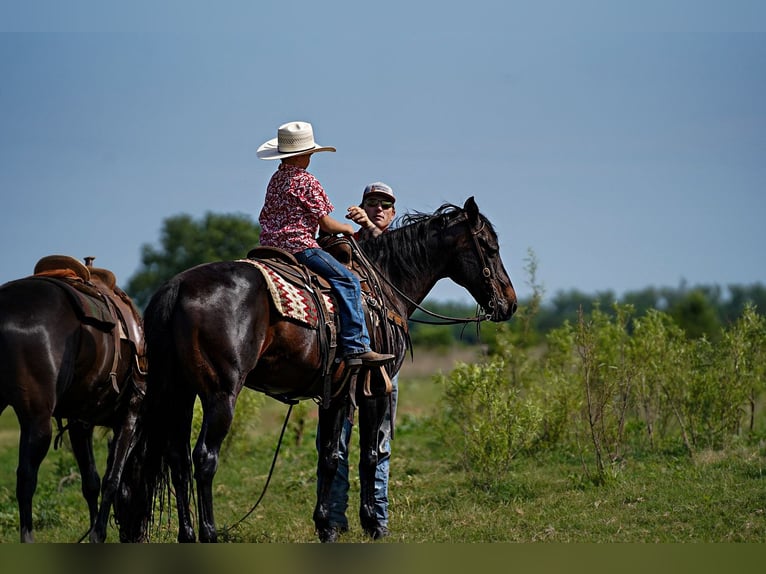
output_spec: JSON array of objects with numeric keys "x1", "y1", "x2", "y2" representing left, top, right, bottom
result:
[{"x1": 358, "y1": 393, "x2": 388, "y2": 539}]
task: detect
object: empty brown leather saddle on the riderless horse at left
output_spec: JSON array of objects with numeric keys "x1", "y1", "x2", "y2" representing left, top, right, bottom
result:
[{"x1": 30, "y1": 255, "x2": 147, "y2": 394}]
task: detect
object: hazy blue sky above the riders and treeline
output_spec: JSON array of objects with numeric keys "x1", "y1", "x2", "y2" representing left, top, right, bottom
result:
[{"x1": 0, "y1": 0, "x2": 766, "y2": 302}]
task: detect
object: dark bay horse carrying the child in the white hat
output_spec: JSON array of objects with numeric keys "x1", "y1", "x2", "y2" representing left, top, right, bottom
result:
[{"x1": 115, "y1": 198, "x2": 516, "y2": 542}]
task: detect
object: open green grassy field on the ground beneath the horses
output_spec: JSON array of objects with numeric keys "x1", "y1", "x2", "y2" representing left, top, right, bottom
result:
[{"x1": 0, "y1": 346, "x2": 766, "y2": 544}]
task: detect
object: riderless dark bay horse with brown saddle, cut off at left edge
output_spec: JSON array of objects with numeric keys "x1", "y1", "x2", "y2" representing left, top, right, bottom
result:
[{"x1": 0, "y1": 256, "x2": 144, "y2": 542}]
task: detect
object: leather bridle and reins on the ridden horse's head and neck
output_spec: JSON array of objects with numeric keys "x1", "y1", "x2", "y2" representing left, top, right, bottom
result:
[{"x1": 349, "y1": 211, "x2": 508, "y2": 325}]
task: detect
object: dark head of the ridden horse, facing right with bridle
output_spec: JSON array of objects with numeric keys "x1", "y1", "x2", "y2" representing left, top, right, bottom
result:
[{"x1": 442, "y1": 197, "x2": 517, "y2": 322}]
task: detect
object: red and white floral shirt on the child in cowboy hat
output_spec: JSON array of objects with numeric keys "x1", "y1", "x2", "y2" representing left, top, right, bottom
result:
[{"x1": 258, "y1": 164, "x2": 335, "y2": 253}]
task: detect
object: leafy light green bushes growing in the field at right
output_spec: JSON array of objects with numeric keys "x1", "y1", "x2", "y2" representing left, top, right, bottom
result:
[{"x1": 440, "y1": 304, "x2": 766, "y2": 484}]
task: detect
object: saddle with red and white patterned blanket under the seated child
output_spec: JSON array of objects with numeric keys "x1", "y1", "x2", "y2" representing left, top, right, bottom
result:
[{"x1": 245, "y1": 241, "x2": 410, "y2": 408}]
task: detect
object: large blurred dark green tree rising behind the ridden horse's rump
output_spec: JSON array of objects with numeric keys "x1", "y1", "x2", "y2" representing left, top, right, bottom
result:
[{"x1": 125, "y1": 212, "x2": 261, "y2": 309}]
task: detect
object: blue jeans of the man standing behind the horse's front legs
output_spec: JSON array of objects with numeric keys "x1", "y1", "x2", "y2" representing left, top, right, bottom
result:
[{"x1": 317, "y1": 373, "x2": 399, "y2": 530}]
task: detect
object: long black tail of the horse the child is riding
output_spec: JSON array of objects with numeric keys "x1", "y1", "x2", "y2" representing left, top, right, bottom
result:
[{"x1": 115, "y1": 279, "x2": 184, "y2": 541}]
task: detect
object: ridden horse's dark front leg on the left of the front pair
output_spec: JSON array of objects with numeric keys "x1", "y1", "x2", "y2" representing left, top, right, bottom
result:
[{"x1": 314, "y1": 400, "x2": 348, "y2": 542}]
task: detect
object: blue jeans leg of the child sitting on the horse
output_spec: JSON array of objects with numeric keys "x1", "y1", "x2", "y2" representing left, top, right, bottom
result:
[{"x1": 295, "y1": 248, "x2": 370, "y2": 357}]
